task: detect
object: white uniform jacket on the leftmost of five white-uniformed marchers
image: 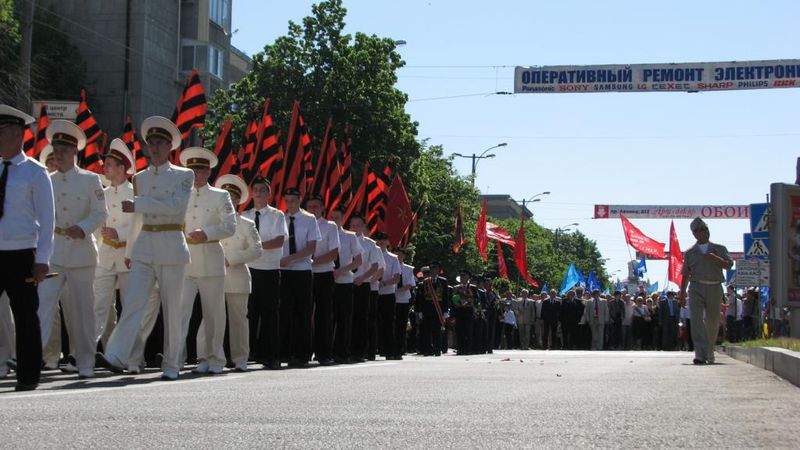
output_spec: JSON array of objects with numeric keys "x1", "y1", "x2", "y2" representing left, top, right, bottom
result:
[{"x1": 50, "y1": 167, "x2": 107, "y2": 267}]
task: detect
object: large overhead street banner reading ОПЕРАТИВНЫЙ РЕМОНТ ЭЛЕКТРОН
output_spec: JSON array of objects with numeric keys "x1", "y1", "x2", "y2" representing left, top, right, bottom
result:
[{"x1": 514, "y1": 59, "x2": 800, "y2": 94}]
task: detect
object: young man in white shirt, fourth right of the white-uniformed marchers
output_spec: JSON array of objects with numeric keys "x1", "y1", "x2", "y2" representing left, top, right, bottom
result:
[{"x1": 331, "y1": 207, "x2": 362, "y2": 364}]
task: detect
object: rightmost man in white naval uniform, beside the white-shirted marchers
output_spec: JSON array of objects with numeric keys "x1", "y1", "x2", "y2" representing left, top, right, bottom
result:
[{"x1": 214, "y1": 175, "x2": 263, "y2": 372}]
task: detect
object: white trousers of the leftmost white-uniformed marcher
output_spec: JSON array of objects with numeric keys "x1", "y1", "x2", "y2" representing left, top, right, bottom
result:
[{"x1": 38, "y1": 265, "x2": 96, "y2": 371}]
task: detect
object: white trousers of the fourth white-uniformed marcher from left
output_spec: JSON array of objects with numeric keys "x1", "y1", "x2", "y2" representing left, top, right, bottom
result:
[{"x1": 183, "y1": 276, "x2": 225, "y2": 367}]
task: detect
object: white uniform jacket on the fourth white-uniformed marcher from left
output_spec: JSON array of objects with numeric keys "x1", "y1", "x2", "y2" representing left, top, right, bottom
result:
[{"x1": 184, "y1": 185, "x2": 238, "y2": 277}]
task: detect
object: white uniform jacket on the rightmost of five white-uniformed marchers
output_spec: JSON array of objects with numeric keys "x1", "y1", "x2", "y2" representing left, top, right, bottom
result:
[{"x1": 222, "y1": 216, "x2": 263, "y2": 294}]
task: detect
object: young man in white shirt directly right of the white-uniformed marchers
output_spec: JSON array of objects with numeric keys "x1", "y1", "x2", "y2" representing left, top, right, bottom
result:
[{"x1": 242, "y1": 177, "x2": 289, "y2": 370}]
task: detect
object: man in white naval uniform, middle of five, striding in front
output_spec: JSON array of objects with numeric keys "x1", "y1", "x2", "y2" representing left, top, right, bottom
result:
[{"x1": 97, "y1": 116, "x2": 194, "y2": 380}]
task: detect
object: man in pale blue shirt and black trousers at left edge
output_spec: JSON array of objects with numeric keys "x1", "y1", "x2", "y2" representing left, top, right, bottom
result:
[{"x1": 0, "y1": 105, "x2": 55, "y2": 391}]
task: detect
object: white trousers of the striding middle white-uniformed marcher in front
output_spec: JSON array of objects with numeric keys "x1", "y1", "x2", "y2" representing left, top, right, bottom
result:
[{"x1": 105, "y1": 261, "x2": 186, "y2": 372}]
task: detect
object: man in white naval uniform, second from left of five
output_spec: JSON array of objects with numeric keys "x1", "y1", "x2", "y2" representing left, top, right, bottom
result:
[{"x1": 94, "y1": 139, "x2": 134, "y2": 344}]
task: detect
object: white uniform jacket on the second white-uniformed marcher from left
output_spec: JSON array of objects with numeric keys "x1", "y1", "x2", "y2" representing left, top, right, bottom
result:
[{"x1": 95, "y1": 182, "x2": 133, "y2": 273}]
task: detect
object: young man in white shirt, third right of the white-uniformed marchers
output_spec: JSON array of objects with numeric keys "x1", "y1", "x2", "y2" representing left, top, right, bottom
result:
[{"x1": 306, "y1": 194, "x2": 339, "y2": 366}]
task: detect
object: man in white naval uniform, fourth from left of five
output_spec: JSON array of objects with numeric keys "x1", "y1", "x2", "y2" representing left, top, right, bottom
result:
[{"x1": 180, "y1": 147, "x2": 236, "y2": 374}]
